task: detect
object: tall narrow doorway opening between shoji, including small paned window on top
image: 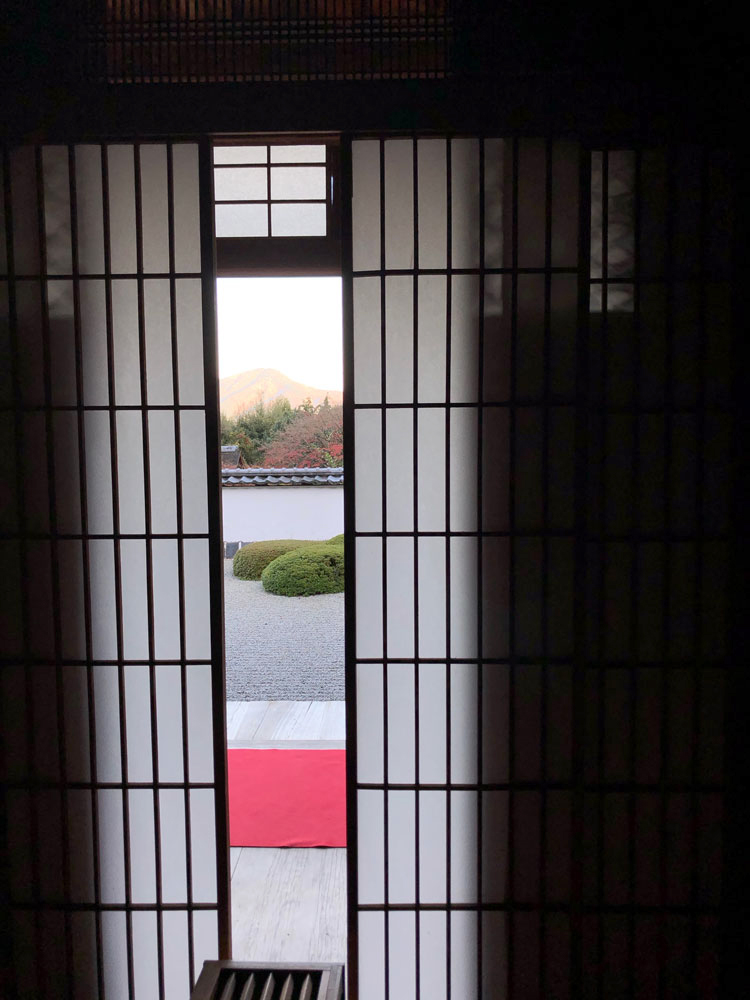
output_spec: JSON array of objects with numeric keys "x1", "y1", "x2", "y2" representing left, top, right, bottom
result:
[{"x1": 214, "y1": 137, "x2": 346, "y2": 963}]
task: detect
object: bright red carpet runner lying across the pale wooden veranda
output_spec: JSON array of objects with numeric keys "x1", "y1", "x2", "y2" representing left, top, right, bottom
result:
[{"x1": 227, "y1": 750, "x2": 346, "y2": 847}]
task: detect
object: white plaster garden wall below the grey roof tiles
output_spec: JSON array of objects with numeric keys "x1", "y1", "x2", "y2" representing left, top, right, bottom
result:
[{"x1": 221, "y1": 486, "x2": 344, "y2": 542}]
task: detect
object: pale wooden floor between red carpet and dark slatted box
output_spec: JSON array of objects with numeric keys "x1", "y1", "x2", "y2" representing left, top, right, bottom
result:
[{"x1": 232, "y1": 847, "x2": 346, "y2": 963}]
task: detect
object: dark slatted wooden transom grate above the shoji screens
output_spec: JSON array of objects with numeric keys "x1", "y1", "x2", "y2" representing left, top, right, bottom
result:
[{"x1": 74, "y1": 0, "x2": 453, "y2": 83}]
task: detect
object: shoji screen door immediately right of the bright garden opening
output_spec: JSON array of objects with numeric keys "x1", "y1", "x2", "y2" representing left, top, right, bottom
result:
[{"x1": 350, "y1": 138, "x2": 581, "y2": 1000}]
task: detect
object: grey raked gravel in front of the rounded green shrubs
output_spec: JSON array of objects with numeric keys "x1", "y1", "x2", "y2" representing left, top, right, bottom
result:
[{"x1": 224, "y1": 559, "x2": 344, "y2": 701}]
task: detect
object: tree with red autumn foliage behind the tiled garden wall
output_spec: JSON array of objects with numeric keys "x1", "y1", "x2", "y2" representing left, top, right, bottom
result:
[{"x1": 264, "y1": 403, "x2": 344, "y2": 469}]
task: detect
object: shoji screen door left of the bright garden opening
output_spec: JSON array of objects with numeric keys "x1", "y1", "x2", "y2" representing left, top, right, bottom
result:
[{"x1": 0, "y1": 142, "x2": 229, "y2": 1000}]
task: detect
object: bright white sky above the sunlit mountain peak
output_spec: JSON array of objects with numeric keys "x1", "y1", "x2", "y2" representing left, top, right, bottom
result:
[{"x1": 217, "y1": 277, "x2": 344, "y2": 389}]
